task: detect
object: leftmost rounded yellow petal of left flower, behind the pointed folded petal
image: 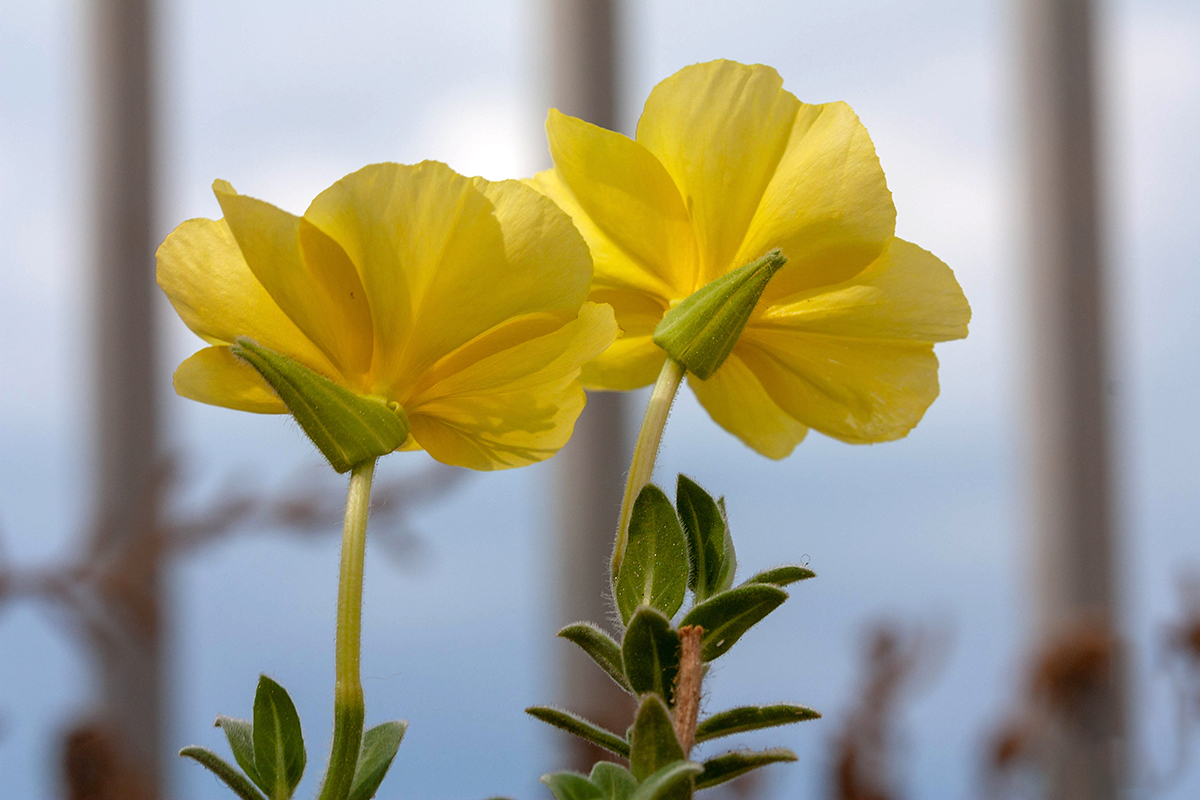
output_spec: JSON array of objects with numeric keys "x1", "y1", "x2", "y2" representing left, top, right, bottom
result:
[{"x1": 157, "y1": 212, "x2": 336, "y2": 374}]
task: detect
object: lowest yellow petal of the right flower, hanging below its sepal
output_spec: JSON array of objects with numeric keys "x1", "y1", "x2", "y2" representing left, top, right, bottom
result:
[{"x1": 688, "y1": 351, "x2": 809, "y2": 458}]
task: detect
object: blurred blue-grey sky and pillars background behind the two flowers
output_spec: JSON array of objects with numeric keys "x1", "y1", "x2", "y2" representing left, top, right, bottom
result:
[{"x1": 0, "y1": 0, "x2": 1200, "y2": 800}]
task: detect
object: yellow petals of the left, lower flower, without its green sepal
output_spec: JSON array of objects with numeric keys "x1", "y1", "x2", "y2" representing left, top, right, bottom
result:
[{"x1": 157, "y1": 162, "x2": 617, "y2": 469}]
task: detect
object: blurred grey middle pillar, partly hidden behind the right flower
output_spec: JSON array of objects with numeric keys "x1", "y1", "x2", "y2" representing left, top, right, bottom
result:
[{"x1": 547, "y1": 0, "x2": 632, "y2": 771}]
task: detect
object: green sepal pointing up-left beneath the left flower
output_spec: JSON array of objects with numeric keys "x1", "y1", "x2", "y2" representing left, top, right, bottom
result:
[{"x1": 229, "y1": 336, "x2": 408, "y2": 473}]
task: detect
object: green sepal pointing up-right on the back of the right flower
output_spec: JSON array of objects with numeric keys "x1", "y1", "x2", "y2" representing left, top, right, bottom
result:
[{"x1": 654, "y1": 248, "x2": 787, "y2": 380}]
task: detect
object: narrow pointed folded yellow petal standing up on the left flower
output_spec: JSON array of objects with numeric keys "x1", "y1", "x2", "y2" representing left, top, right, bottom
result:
[{"x1": 212, "y1": 181, "x2": 372, "y2": 381}]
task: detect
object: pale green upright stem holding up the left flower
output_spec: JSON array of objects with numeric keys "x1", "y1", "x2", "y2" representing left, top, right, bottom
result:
[{"x1": 319, "y1": 458, "x2": 376, "y2": 800}]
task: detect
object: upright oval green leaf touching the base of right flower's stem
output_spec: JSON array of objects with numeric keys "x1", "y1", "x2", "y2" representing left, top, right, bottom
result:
[{"x1": 613, "y1": 483, "x2": 689, "y2": 624}]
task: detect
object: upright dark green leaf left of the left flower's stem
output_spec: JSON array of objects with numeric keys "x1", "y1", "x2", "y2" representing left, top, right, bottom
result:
[{"x1": 253, "y1": 675, "x2": 306, "y2": 800}]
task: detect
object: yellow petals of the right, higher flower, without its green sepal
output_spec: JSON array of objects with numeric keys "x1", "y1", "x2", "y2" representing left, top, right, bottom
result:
[{"x1": 528, "y1": 61, "x2": 971, "y2": 458}]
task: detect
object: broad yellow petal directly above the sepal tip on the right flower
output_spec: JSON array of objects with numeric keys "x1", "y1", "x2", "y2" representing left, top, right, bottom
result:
[{"x1": 734, "y1": 103, "x2": 896, "y2": 301}]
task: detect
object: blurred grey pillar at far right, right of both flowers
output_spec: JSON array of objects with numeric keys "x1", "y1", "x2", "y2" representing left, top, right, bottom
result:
[{"x1": 1020, "y1": 0, "x2": 1126, "y2": 800}]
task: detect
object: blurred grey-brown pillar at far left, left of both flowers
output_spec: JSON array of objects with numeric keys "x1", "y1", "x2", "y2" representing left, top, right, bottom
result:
[{"x1": 88, "y1": 0, "x2": 164, "y2": 798}]
